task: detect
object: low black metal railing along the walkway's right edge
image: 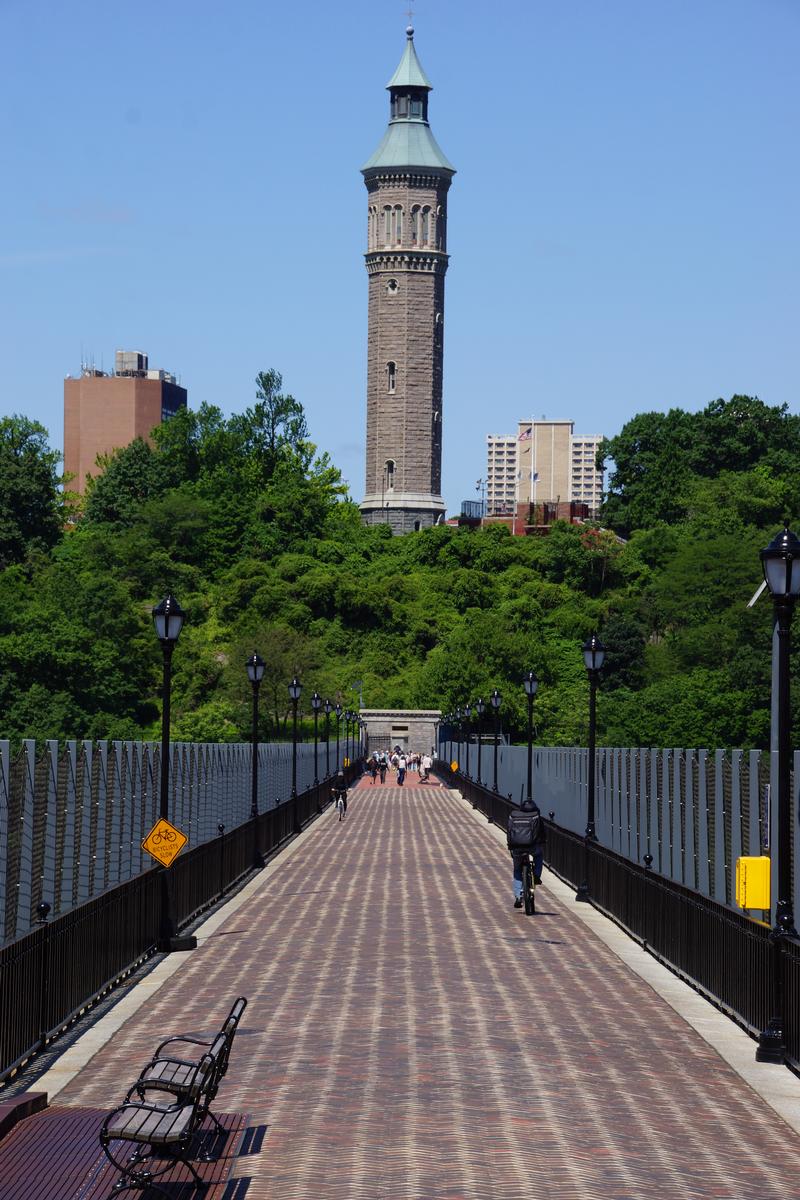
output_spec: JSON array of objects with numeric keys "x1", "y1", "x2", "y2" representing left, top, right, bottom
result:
[{"x1": 437, "y1": 762, "x2": 800, "y2": 1070}]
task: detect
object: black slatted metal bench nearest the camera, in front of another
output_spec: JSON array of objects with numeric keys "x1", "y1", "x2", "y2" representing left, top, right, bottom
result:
[{"x1": 100, "y1": 1052, "x2": 216, "y2": 1196}]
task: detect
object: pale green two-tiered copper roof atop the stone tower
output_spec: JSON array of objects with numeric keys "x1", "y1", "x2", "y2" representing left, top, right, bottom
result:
[{"x1": 361, "y1": 25, "x2": 456, "y2": 175}]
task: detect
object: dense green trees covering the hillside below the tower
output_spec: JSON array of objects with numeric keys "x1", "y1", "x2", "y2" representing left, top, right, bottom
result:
[{"x1": 0, "y1": 384, "x2": 800, "y2": 746}]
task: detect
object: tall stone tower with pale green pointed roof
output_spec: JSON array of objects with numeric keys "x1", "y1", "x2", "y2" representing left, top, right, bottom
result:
[{"x1": 361, "y1": 26, "x2": 456, "y2": 534}]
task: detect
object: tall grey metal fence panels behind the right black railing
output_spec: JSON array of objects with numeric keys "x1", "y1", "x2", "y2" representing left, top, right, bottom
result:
[{"x1": 440, "y1": 738, "x2": 800, "y2": 920}]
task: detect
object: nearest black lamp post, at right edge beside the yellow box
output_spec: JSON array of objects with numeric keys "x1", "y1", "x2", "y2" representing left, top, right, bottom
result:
[{"x1": 756, "y1": 521, "x2": 800, "y2": 1062}]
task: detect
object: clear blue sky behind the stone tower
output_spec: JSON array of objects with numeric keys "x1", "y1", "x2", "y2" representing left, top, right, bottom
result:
[{"x1": 0, "y1": 0, "x2": 800, "y2": 511}]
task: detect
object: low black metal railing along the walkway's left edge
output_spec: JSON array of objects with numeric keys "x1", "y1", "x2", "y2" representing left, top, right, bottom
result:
[{"x1": 0, "y1": 766, "x2": 359, "y2": 1094}]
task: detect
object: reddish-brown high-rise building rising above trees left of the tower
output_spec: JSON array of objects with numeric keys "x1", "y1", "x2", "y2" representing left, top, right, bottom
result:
[{"x1": 64, "y1": 350, "x2": 187, "y2": 496}]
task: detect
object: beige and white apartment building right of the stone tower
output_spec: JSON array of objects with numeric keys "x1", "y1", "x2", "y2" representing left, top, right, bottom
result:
[{"x1": 486, "y1": 420, "x2": 603, "y2": 516}]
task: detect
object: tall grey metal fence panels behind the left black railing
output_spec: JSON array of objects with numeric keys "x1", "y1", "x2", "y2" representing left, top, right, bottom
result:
[{"x1": 0, "y1": 740, "x2": 335, "y2": 944}]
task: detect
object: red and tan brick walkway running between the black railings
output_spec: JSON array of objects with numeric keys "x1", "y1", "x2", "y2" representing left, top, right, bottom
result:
[{"x1": 45, "y1": 776, "x2": 800, "y2": 1200}]
